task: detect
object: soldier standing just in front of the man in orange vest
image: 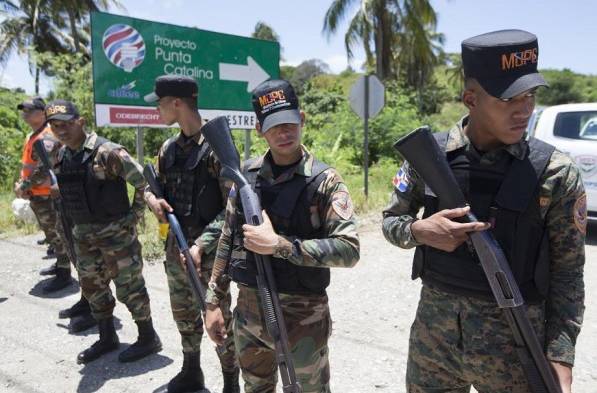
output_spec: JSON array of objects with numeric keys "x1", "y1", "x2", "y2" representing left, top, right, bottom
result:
[{"x1": 46, "y1": 100, "x2": 162, "y2": 363}]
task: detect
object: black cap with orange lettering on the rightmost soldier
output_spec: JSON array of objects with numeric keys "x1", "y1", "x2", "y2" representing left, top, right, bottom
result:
[{"x1": 462, "y1": 30, "x2": 547, "y2": 99}]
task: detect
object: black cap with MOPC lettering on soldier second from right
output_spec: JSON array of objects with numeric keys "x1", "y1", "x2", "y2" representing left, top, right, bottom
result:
[{"x1": 252, "y1": 79, "x2": 301, "y2": 133}]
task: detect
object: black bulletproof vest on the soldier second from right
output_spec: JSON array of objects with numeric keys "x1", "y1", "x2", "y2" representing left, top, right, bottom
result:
[{"x1": 228, "y1": 160, "x2": 330, "y2": 295}]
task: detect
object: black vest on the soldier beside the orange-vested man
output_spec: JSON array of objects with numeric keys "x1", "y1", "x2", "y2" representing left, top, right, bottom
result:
[{"x1": 57, "y1": 137, "x2": 131, "y2": 224}]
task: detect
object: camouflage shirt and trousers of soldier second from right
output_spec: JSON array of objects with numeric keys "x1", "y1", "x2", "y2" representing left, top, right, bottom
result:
[{"x1": 207, "y1": 148, "x2": 359, "y2": 393}]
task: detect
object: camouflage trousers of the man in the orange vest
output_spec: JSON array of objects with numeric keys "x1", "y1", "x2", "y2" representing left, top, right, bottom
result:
[{"x1": 29, "y1": 196, "x2": 70, "y2": 269}]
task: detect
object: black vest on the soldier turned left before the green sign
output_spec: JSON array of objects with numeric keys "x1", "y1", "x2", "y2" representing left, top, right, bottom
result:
[{"x1": 160, "y1": 141, "x2": 223, "y2": 236}]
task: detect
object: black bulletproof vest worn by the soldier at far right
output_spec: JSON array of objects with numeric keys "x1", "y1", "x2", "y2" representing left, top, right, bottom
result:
[{"x1": 413, "y1": 133, "x2": 554, "y2": 302}]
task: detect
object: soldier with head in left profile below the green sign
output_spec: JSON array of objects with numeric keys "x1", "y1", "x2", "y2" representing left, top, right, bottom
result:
[{"x1": 145, "y1": 75, "x2": 240, "y2": 393}]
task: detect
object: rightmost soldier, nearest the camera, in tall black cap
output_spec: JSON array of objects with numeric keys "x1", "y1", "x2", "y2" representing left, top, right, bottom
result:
[{"x1": 383, "y1": 30, "x2": 587, "y2": 393}]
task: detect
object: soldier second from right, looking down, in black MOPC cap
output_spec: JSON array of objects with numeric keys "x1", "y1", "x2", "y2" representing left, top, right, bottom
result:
[{"x1": 206, "y1": 80, "x2": 359, "y2": 393}]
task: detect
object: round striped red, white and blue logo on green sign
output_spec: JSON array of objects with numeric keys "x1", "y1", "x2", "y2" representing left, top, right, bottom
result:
[{"x1": 102, "y1": 24, "x2": 145, "y2": 72}]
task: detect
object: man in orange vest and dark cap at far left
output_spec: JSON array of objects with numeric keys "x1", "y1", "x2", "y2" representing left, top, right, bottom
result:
[{"x1": 14, "y1": 97, "x2": 72, "y2": 293}]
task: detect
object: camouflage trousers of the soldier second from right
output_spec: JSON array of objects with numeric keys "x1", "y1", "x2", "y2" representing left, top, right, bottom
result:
[{"x1": 233, "y1": 285, "x2": 332, "y2": 393}]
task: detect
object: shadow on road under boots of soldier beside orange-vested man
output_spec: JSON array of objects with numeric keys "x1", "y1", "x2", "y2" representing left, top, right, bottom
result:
[{"x1": 77, "y1": 345, "x2": 173, "y2": 393}]
